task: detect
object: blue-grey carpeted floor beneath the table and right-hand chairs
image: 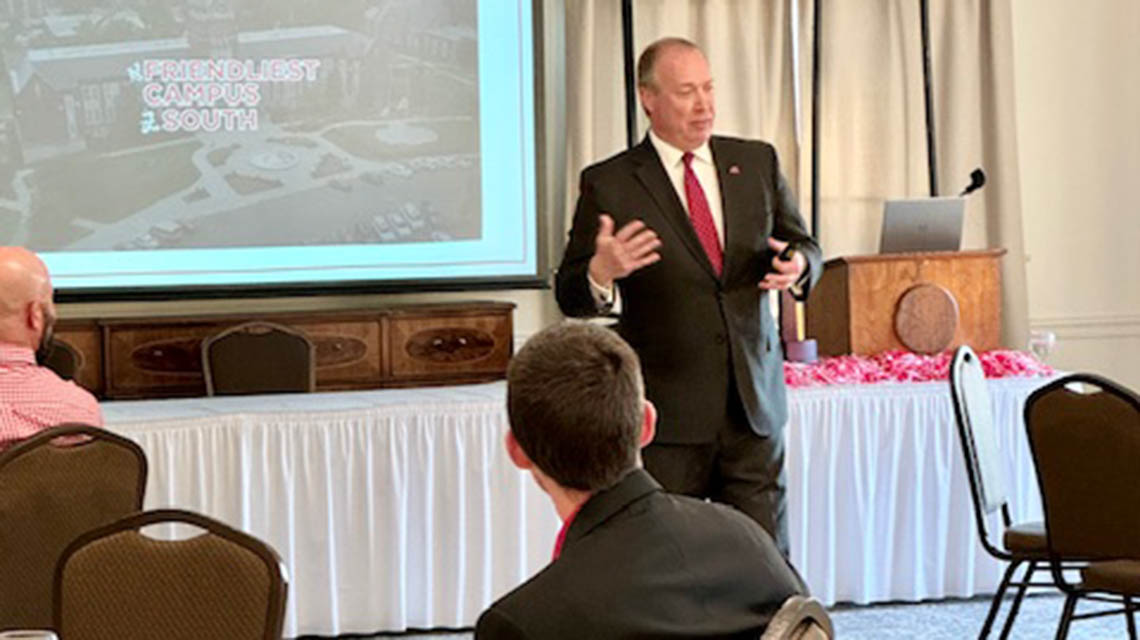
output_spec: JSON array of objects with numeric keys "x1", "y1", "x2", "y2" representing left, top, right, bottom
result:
[{"x1": 353, "y1": 594, "x2": 1127, "y2": 640}]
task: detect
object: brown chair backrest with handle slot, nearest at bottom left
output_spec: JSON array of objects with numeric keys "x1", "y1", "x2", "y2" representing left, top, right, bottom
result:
[{"x1": 55, "y1": 510, "x2": 286, "y2": 640}]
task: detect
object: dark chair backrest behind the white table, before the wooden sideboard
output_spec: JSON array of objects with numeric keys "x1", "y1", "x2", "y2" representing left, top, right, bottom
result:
[{"x1": 202, "y1": 322, "x2": 317, "y2": 396}]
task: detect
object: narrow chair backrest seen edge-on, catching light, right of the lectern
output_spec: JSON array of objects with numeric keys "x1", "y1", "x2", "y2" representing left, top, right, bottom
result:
[{"x1": 950, "y1": 345, "x2": 1008, "y2": 513}]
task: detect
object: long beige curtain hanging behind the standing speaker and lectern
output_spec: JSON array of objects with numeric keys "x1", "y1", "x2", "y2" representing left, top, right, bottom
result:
[{"x1": 565, "y1": 0, "x2": 1028, "y2": 348}]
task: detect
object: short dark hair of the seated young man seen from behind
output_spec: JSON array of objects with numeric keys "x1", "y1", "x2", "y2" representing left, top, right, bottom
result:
[{"x1": 507, "y1": 322, "x2": 644, "y2": 492}]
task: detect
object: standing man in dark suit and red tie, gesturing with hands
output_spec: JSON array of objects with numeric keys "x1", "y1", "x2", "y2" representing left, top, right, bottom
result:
[{"x1": 556, "y1": 38, "x2": 821, "y2": 553}]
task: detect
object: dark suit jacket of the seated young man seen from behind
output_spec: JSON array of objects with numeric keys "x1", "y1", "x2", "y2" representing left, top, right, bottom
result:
[{"x1": 475, "y1": 470, "x2": 804, "y2": 640}]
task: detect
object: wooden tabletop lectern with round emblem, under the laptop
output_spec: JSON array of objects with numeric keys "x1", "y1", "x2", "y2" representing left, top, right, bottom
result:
[{"x1": 807, "y1": 249, "x2": 1005, "y2": 356}]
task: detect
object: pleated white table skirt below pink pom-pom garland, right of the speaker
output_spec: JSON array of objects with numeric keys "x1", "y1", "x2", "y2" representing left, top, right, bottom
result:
[{"x1": 787, "y1": 379, "x2": 1047, "y2": 605}]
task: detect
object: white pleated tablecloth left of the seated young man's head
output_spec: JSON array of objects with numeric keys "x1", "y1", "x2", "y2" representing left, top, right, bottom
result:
[{"x1": 103, "y1": 383, "x2": 560, "y2": 635}]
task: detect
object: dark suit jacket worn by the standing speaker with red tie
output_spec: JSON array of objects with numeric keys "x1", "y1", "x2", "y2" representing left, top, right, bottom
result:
[{"x1": 555, "y1": 137, "x2": 822, "y2": 444}]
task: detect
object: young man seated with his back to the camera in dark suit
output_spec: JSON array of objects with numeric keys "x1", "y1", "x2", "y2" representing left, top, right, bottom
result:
[{"x1": 475, "y1": 321, "x2": 804, "y2": 640}]
